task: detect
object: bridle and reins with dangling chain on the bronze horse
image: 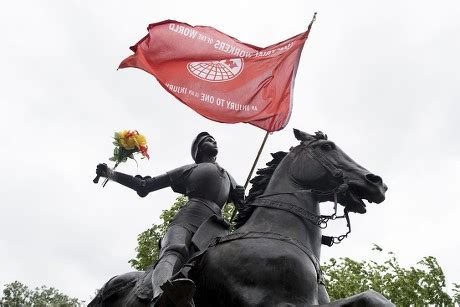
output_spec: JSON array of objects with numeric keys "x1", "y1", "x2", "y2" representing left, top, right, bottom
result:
[{"x1": 250, "y1": 139, "x2": 351, "y2": 246}]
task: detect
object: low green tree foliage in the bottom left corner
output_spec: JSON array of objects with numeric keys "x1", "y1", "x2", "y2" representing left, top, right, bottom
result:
[{"x1": 0, "y1": 281, "x2": 83, "y2": 307}]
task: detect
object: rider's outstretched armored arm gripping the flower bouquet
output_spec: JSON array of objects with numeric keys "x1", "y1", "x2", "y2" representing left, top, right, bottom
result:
[{"x1": 96, "y1": 163, "x2": 171, "y2": 197}]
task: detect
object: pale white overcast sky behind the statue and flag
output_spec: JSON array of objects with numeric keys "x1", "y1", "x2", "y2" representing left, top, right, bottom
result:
[{"x1": 0, "y1": 0, "x2": 460, "y2": 300}]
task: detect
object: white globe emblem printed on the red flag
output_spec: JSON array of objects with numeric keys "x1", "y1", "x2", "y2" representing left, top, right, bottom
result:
[{"x1": 187, "y1": 58, "x2": 244, "y2": 82}]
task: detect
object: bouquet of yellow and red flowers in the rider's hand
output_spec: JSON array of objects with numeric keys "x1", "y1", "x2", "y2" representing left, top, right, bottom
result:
[{"x1": 93, "y1": 130, "x2": 150, "y2": 187}]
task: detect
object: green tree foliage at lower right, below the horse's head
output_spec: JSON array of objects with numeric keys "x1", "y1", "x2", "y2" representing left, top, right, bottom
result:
[{"x1": 322, "y1": 244, "x2": 460, "y2": 306}]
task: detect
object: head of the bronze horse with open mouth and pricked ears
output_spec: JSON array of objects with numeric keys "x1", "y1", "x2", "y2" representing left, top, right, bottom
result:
[{"x1": 288, "y1": 129, "x2": 387, "y2": 213}]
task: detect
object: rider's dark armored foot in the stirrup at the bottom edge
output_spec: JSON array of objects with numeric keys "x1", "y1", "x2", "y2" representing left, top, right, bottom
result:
[{"x1": 159, "y1": 278, "x2": 195, "y2": 307}]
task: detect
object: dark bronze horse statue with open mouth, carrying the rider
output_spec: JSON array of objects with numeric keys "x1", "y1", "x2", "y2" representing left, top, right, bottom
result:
[{"x1": 90, "y1": 129, "x2": 392, "y2": 306}]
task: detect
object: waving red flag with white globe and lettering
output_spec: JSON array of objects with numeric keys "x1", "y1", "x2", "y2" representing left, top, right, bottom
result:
[{"x1": 120, "y1": 18, "x2": 314, "y2": 132}]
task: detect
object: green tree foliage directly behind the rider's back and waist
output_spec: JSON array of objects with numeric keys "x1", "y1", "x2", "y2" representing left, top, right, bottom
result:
[{"x1": 128, "y1": 196, "x2": 234, "y2": 271}]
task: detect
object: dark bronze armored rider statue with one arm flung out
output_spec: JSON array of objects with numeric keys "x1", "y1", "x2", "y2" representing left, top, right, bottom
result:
[{"x1": 96, "y1": 132, "x2": 244, "y2": 306}]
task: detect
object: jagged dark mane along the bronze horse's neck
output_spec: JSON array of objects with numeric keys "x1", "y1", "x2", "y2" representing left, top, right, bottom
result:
[{"x1": 235, "y1": 151, "x2": 288, "y2": 228}]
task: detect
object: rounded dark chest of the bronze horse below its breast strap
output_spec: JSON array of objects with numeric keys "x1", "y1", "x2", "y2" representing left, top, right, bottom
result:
[{"x1": 196, "y1": 238, "x2": 318, "y2": 306}]
